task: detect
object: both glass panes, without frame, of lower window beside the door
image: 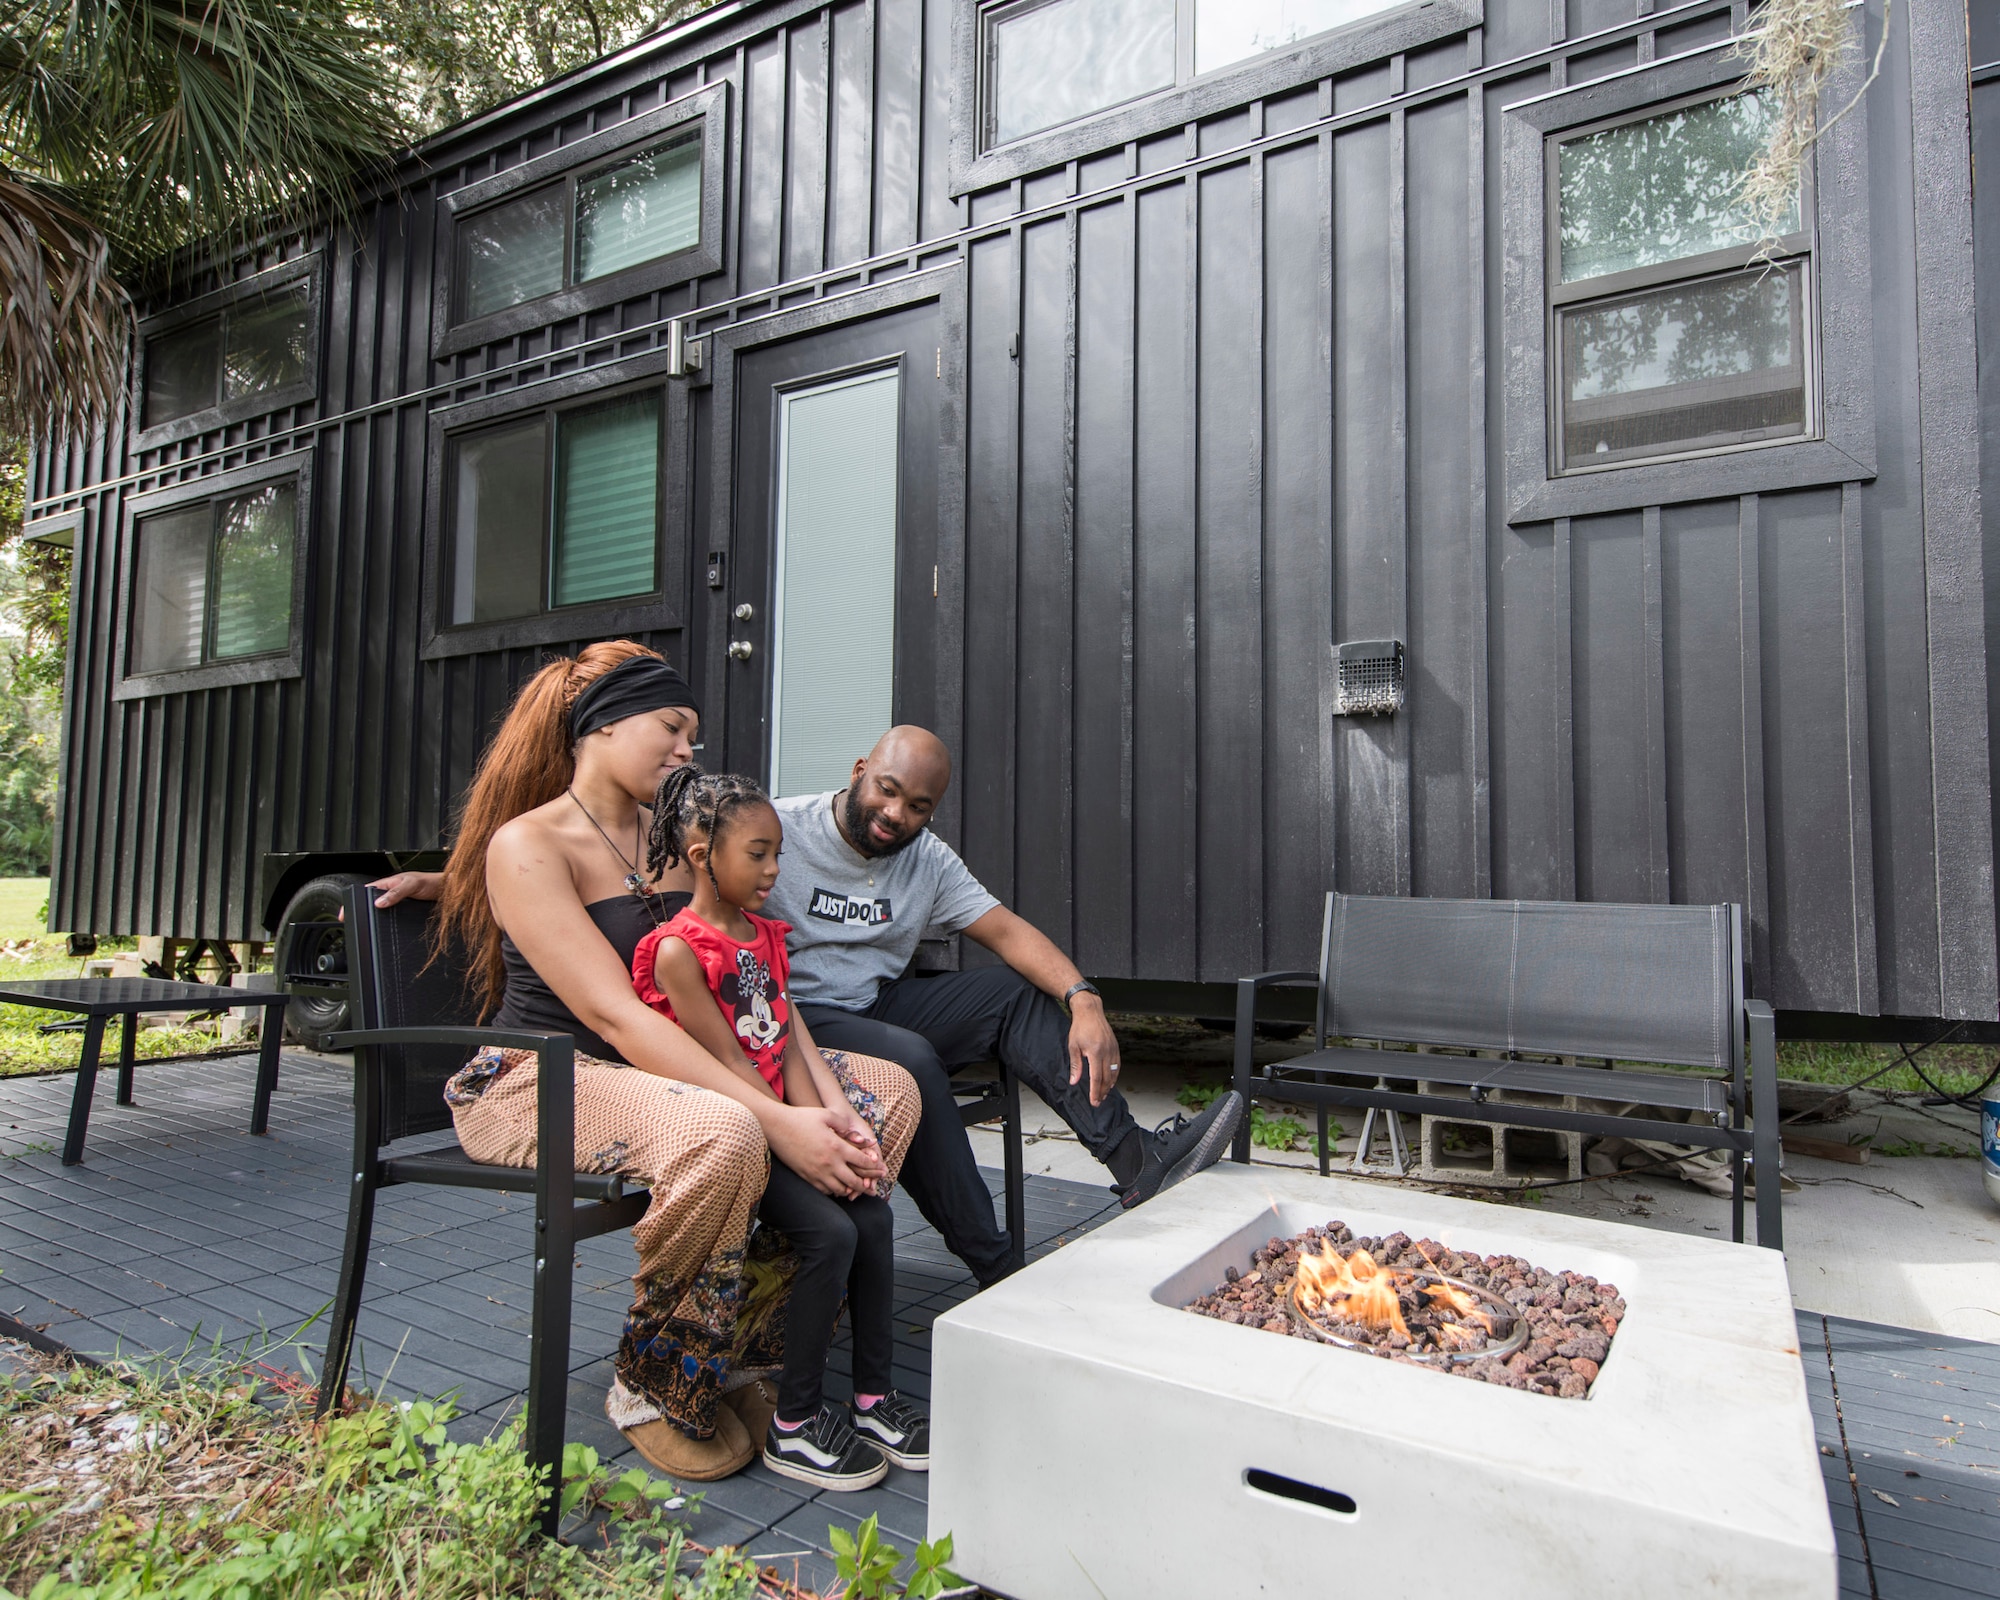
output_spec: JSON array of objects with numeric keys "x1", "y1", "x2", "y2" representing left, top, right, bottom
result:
[{"x1": 440, "y1": 386, "x2": 666, "y2": 628}]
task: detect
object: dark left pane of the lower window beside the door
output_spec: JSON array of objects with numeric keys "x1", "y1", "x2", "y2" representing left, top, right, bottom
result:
[{"x1": 452, "y1": 414, "x2": 548, "y2": 624}]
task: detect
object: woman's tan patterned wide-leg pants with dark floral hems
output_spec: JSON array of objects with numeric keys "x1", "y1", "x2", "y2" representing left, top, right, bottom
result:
[{"x1": 444, "y1": 1050, "x2": 920, "y2": 1438}]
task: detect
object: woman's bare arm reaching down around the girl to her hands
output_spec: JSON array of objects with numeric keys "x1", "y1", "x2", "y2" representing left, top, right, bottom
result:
[{"x1": 486, "y1": 832, "x2": 888, "y2": 1194}]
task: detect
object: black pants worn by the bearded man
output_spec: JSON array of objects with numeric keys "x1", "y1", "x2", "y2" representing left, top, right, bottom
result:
[{"x1": 798, "y1": 966, "x2": 1138, "y2": 1284}]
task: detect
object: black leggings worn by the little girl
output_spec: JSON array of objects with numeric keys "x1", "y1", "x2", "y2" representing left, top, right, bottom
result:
[{"x1": 756, "y1": 1158, "x2": 896, "y2": 1416}]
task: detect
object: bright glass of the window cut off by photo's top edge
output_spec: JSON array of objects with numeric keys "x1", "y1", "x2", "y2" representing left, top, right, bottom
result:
[{"x1": 980, "y1": 0, "x2": 1408, "y2": 148}]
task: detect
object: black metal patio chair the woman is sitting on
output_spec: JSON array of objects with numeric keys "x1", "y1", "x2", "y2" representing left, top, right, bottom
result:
[{"x1": 318, "y1": 884, "x2": 648, "y2": 1536}]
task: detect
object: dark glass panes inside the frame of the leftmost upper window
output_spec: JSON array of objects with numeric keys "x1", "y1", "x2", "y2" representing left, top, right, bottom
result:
[{"x1": 140, "y1": 280, "x2": 312, "y2": 428}]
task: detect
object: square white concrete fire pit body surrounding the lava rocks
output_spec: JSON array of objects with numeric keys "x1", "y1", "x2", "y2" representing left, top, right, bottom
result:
[{"x1": 930, "y1": 1164, "x2": 1836, "y2": 1600}]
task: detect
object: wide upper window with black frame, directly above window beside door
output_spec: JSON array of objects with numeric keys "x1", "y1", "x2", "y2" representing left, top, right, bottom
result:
[{"x1": 436, "y1": 84, "x2": 728, "y2": 356}]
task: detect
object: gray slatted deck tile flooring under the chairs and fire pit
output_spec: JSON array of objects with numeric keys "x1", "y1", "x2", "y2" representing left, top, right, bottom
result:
[{"x1": 0, "y1": 1056, "x2": 2000, "y2": 1600}]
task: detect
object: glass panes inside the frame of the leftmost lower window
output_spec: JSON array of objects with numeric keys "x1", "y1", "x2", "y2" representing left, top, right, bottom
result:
[{"x1": 130, "y1": 482, "x2": 298, "y2": 674}]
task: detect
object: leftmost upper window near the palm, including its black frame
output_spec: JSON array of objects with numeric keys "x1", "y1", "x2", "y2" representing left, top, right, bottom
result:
[{"x1": 134, "y1": 260, "x2": 318, "y2": 448}]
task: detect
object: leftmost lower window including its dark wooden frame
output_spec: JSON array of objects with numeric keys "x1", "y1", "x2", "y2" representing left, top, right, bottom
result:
[{"x1": 114, "y1": 452, "x2": 312, "y2": 700}]
